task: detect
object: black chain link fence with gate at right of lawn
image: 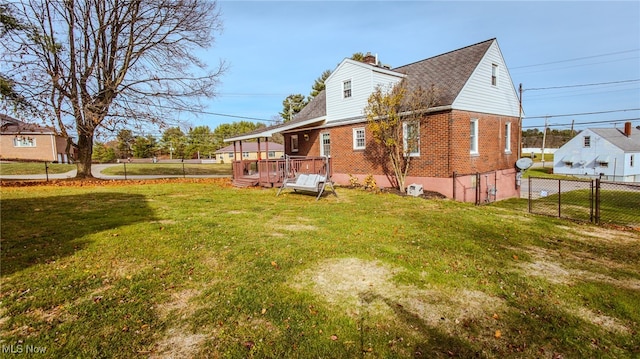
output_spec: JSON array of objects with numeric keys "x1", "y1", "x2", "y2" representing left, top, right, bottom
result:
[{"x1": 528, "y1": 177, "x2": 640, "y2": 227}]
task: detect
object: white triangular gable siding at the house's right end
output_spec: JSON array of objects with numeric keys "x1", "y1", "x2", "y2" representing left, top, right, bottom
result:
[{"x1": 452, "y1": 41, "x2": 520, "y2": 117}]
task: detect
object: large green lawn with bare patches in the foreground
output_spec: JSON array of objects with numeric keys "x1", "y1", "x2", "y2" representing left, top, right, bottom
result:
[{"x1": 0, "y1": 180, "x2": 640, "y2": 358}]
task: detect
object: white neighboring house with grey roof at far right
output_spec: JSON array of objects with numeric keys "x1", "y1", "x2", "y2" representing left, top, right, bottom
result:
[{"x1": 553, "y1": 122, "x2": 640, "y2": 182}]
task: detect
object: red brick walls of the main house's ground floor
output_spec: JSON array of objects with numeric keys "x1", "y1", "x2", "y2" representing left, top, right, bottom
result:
[{"x1": 285, "y1": 111, "x2": 518, "y2": 186}]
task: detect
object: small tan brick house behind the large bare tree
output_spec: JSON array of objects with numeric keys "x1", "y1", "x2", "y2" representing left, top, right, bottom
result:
[{"x1": 0, "y1": 114, "x2": 73, "y2": 163}]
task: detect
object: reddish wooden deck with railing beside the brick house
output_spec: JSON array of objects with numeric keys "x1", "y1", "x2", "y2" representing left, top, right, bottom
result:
[{"x1": 233, "y1": 156, "x2": 331, "y2": 188}]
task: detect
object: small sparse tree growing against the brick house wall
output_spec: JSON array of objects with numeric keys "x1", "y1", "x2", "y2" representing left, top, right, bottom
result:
[{"x1": 364, "y1": 80, "x2": 438, "y2": 192}]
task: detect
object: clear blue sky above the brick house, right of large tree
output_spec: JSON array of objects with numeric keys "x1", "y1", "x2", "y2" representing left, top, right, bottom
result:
[{"x1": 189, "y1": 1, "x2": 640, "y2": 129}]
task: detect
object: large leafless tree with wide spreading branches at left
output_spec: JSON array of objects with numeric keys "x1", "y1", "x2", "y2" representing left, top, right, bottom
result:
[{"x1": 4, "y1": 0, "x2": 225, "y2": 178}]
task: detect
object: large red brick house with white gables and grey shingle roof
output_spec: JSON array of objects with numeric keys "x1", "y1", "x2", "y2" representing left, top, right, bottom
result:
[{"x1": 225, "y1": 39, "x2": 521, "y2": 202}]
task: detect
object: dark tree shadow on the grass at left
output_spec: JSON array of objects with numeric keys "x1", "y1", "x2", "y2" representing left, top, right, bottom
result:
[{"x1": 0, "y1": 193, "x2": 154, "y2": 277}]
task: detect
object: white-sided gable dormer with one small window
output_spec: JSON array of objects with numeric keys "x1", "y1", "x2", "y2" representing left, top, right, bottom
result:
[{"x1": 325, "y1": 59, "x2": 404, "y2": 123}]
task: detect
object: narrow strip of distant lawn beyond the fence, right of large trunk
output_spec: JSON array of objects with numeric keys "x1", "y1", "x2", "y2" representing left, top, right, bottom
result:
[{"x1": 102, "y1": 163, "x2": 231, "y2": 176}]
